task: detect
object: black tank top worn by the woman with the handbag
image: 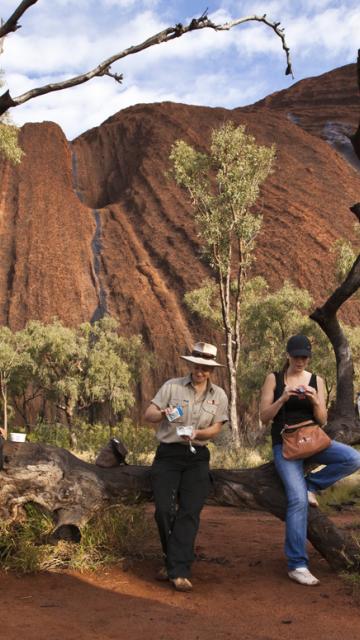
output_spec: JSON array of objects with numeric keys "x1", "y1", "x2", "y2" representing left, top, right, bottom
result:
[{"x1": 271, "y1": 371, "x2": 317, "y2": 446}]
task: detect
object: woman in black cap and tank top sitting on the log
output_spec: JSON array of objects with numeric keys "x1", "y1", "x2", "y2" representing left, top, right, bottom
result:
[{"x1": 260, "y1": 334, "x2": 360, "y2": 586}]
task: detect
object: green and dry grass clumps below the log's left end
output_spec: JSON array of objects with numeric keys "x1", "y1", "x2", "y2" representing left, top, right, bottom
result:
[{"x1": 0, "y1": 505, "x2": 148, "y2": 574}]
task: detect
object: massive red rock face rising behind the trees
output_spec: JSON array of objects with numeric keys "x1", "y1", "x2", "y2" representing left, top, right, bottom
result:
[{"x1": 0, "y1": 65, "x2": 360, "y2": 398}]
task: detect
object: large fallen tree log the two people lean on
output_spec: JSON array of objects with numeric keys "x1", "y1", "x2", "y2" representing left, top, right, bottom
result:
[{"x1": 0, "y1": 432, "x2": 360, "y2": 570}]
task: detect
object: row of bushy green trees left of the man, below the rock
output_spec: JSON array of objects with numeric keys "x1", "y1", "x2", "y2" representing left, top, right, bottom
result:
[{"x1": 0, "y1": 317, "x2": 149, "y2": 438}]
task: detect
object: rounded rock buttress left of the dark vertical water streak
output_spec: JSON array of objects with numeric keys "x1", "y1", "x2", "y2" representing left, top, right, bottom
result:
[{"x1": 0, "y1": 123, "x2": 97, "y2": 329}]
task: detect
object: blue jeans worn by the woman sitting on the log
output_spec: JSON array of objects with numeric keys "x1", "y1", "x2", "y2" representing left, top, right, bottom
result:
[{"x1": 273, "y1": 440, "x2": 360, "y2": 571}]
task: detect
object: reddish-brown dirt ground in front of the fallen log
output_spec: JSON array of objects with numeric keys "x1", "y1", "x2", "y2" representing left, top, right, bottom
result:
[{"x1": 0, "y1": 507, "x2": 360, "y2": 640}]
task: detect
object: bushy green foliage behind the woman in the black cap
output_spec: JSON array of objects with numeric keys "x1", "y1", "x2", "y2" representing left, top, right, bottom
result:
[{"x1": 185, "y1": 276, "x2": 342, "y2": 406}]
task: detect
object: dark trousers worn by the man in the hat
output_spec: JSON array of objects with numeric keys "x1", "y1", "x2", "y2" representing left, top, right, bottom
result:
[{"x1": 151, "y1": 443, "x2": 210, "y2": 578}]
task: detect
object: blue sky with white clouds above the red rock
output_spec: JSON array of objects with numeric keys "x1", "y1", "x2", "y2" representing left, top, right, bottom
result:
[{"x1": 0, "y1": 0, "x2": 360, "y2": 140}]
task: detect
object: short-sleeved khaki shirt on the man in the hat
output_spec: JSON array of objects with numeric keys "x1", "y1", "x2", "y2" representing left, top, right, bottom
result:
[{"x1": 151, "y1": 374, "x2": 229, "y2": 446}]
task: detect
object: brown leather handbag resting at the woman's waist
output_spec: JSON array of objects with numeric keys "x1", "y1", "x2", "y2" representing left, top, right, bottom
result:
[{"x1": 281, "y1": 420, "x2": 331, "y2": 460}]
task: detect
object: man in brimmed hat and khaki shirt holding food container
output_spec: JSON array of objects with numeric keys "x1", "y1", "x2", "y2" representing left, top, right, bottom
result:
[{"x1": 145, "y1": 342, "x2": 228, "y2": 591}]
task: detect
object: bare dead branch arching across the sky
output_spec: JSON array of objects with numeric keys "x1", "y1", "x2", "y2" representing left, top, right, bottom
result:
[{"x1": 0, "y1": 7, "x2": 292, "y2": 115}]
